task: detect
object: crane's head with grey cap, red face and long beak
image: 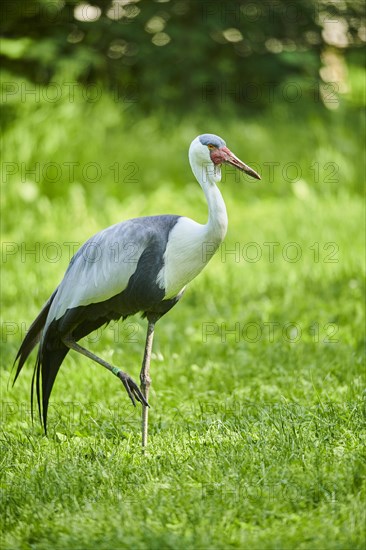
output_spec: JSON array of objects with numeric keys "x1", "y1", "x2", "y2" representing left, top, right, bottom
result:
[{"x1": 189, "y1": 134, "x2": 261, "y2": 180}]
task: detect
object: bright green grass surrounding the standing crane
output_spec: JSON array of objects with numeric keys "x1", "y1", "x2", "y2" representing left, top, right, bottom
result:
[{"x1": 1, "y1": 86, "x2": 365, "y2": 550}]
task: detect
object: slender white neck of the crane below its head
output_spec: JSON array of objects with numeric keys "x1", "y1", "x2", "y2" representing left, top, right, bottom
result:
[{"x1": 189, "y1": 155, "x2": 228, "y2": 246}]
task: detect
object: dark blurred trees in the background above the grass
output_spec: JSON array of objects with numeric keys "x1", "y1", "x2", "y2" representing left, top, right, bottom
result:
[{"x1": 1, "y1": 0, "x2": 366, "y2": 112}]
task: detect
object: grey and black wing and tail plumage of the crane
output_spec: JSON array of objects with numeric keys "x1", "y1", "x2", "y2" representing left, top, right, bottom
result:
[{"x1": 14, "y1": 215, "x2": 181, "y2": 429}]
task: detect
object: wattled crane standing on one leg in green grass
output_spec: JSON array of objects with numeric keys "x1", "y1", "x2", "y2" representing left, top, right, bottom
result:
[{"x1": 13, "y1": 133, "x2": 261, "y2": 449}]
